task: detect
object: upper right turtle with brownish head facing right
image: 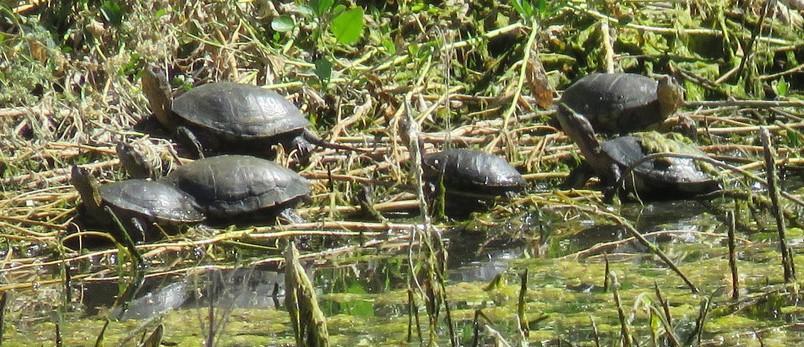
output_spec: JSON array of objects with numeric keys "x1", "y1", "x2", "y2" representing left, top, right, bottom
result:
[{"x1": 550, "y1": 73, "x2": 684, "y2": 135}]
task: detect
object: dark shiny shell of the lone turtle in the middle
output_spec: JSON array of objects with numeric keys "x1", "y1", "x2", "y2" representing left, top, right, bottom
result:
[{"x1": 422, "y1": 149, "x2": 525, "y2": 195}]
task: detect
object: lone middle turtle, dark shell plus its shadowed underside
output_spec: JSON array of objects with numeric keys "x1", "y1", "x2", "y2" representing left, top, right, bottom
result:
[{"x1": 422, "y1": 149, "x2": 526, "y2": 216}]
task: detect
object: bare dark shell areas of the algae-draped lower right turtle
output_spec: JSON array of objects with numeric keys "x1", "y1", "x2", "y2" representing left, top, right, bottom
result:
[{"x1": 601, "y1": 136, "x2": 720, "y2": 198}]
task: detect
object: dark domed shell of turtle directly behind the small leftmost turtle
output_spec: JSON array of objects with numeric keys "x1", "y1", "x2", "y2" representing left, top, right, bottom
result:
[{"x1": 166, "y1": 155, "x2": 310, "y2": 219}]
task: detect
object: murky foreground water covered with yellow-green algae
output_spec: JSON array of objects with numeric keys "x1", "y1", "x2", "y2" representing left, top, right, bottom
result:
[{"x1": 4, "y1": 196, "x2": 804, "y2": 345}]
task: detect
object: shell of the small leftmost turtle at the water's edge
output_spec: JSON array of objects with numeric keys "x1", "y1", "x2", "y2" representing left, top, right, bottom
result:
[{"x1": 100, "y1": 179, "x2": 204, "y2": 224}]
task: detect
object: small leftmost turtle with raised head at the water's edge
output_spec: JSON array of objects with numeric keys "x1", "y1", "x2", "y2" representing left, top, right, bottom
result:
[{"x1": 70, "y1": 166, "x2": 206, "y2": 241}]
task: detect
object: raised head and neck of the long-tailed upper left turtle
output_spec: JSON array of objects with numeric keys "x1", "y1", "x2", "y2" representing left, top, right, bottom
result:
[{"x1": 142, "y1": 64, "x2": 176, "y2": 130}]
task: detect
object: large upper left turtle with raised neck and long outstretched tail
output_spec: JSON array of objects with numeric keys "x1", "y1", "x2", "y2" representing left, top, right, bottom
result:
[{"x1": 142, "y1": 65, "x2": 362, "y2": 159}]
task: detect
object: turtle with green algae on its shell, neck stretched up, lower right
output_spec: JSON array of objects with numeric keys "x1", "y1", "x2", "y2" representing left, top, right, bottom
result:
[{"x1": 558, "y1": 104, "x2": 721, "y2": 201}]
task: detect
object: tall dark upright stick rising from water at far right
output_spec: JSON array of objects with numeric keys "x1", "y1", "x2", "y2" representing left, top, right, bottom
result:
[{"x1": 759, "y1": 127, "x2": 795, "y2": 282}]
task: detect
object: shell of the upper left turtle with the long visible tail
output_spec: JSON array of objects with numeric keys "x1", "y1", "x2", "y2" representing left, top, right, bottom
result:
[{"x1": 172, "y1": 82, "x2": 309, "y2": 140}]
